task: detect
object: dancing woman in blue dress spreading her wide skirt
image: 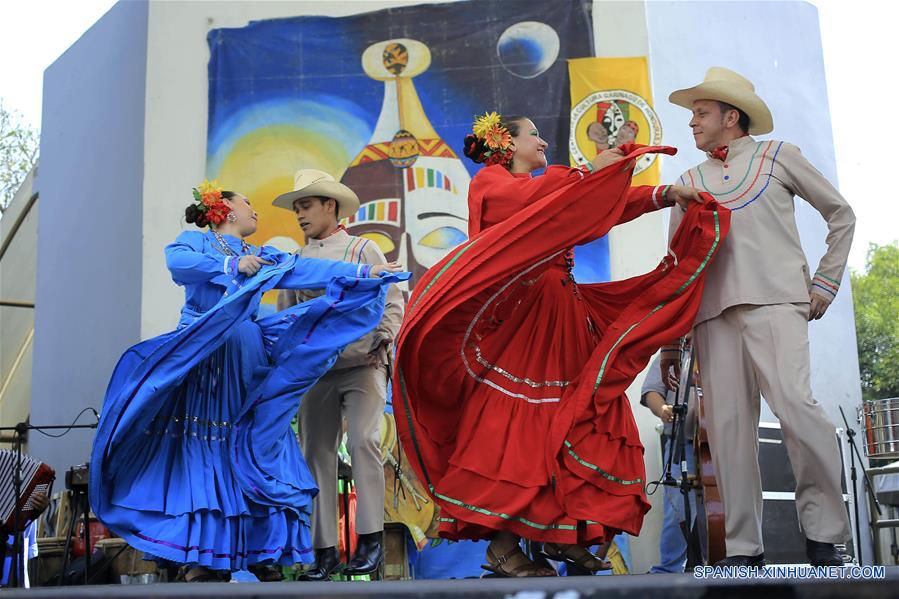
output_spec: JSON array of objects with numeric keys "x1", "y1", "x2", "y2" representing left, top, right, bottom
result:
[{"x1": 90, "y1": 182, "x2": 409, "y2": 580}]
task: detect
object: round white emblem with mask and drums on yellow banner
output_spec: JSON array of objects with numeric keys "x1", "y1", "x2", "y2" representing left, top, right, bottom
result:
[{"x1": 568, "y1": 89, "x2": 662, "y2": 175}]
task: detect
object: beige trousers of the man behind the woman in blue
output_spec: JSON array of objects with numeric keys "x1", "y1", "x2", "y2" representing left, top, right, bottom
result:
[{"x1": 300, "y1": 366, "x2": 387, "y2": 549}]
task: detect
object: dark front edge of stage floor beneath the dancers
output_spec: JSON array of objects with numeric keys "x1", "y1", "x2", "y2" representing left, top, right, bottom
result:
[{"x1": 3, "y1": 567, "x2": 899, "y2": 599}]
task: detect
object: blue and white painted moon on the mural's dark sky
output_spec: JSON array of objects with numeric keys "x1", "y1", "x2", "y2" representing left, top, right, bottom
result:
[{"x1": 496, "y1": 21, "x2": 559, "y2": 79}]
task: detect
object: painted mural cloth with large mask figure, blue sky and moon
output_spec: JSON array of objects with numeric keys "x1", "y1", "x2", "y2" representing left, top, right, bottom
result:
[{"x1": 206, "y1": 0, "x2": 608, "y2": 302}]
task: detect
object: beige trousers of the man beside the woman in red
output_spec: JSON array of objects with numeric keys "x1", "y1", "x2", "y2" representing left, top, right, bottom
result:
[{"x1": 694, "y1": 303, "x2": 850, "y2": 556}]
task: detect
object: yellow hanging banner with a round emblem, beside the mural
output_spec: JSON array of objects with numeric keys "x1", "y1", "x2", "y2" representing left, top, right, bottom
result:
[{"x1": 568, "y1": 56, "x2": 662, "y2": 185}]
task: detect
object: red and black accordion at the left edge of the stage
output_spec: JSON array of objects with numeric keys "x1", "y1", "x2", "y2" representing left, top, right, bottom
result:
[{"x1": 0, "y1": 449, "x2": 56, "y2": 532}]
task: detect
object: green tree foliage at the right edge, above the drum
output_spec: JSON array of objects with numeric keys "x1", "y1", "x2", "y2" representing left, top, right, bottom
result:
[{"x1": 850, "y1": 242, "x2": 899, "y2": 399}]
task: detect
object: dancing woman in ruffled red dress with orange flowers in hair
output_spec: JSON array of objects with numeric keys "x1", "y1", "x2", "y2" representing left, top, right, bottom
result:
[{"x1": 393, "y1": 113, "x2": 730, "y2": 576}]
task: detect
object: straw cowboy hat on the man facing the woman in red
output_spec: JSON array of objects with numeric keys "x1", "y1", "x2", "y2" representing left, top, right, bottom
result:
[{"x1": 668, "y1": 67, "x2": 774, "y2": 135}]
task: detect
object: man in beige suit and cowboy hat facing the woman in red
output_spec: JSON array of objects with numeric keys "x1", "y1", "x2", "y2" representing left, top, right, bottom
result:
[{"x1": 662, "y1": 67, "x2": 855, "y2": 566}]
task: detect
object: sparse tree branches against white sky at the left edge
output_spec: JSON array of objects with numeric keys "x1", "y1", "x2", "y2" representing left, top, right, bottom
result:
[{"x1": 0, "y1": 99, "x2": 38, "y2": 214}]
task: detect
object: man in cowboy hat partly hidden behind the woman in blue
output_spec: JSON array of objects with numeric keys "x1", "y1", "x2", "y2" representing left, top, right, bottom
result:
[{"x1": 274, "y1": 169, "x2": 403, "y2": 580}]
